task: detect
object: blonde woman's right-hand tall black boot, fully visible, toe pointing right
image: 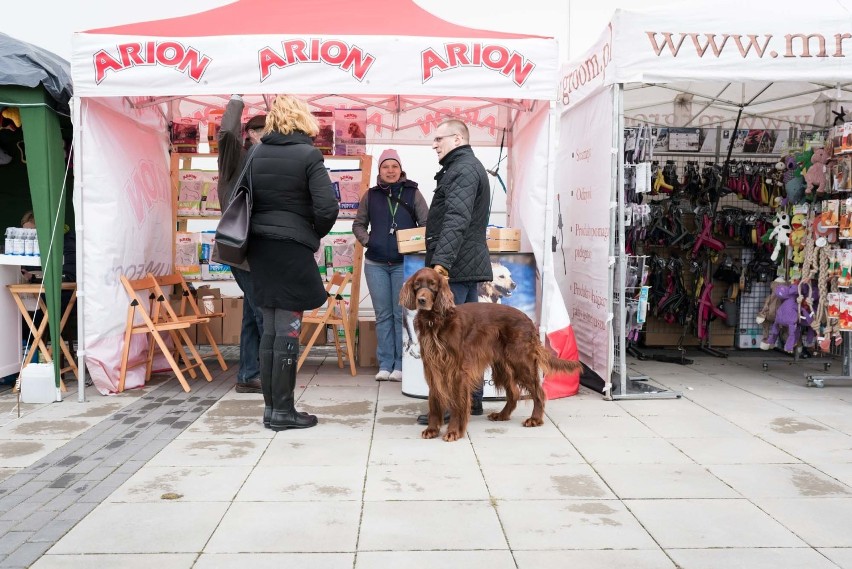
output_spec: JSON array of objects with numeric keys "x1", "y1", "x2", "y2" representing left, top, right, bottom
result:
[{"x1": 269, "y1": 338, "x2": 317, "y2": 431}]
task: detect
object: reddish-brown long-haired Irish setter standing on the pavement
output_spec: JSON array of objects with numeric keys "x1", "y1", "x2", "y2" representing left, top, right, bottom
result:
[{"x1": 399, "y1": 268, "x2": 582, "y2": 442}]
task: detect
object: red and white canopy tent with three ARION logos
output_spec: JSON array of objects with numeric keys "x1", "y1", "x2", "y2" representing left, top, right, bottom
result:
[{"x1": 72, "y1": 0, "x2": 558, "y2": 398}]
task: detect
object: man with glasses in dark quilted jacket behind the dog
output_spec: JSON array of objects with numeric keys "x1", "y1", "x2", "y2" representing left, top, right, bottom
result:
[{"x1": 418, "y1": 119, "x2": 493, "y2": 419}]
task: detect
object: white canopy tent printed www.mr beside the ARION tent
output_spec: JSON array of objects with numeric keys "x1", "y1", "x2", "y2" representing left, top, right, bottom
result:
[{"x1": 544, "y1": 0, "x2": 852, "y2": 394}]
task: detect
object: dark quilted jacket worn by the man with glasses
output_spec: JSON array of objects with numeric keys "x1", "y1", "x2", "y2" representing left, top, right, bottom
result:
[{"x1": 426, "y1": 145, "x2": 494, "y2": 282}]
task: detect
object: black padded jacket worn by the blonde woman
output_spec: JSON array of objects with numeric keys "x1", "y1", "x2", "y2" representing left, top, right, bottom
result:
[{"x1": 251, "y1": 132, "x2": 338, "y2": 251}]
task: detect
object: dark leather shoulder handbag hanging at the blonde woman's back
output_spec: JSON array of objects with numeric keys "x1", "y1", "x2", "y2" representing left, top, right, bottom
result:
[{"x1": 216, "y1": 145, "x2": 258, "y2": 265}]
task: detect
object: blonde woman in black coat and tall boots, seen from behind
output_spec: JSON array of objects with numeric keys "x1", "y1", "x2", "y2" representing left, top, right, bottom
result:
[{"x1": 248, "y1": 95, "x2": 338, "y2": 431}]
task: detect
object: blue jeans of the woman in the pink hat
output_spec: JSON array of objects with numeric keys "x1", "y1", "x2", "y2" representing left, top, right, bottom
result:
[{"x1": 364, "y1": 263, "x2": 402, "y2": 371}]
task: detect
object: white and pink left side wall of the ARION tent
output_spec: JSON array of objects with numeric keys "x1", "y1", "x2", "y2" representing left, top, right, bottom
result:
[{"x1": 74, "y1": 95, "x2": 172, "y2": 395}]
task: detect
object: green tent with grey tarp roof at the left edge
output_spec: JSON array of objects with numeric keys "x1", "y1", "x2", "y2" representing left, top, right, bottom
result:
[{"x1": 0, "y1": 33, "x2": 73, "y2": 386}]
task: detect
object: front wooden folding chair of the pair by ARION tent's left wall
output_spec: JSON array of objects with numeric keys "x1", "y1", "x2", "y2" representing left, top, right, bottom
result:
[{"x1": 118, "y1": 275, "x2": 213, "y2": 392}]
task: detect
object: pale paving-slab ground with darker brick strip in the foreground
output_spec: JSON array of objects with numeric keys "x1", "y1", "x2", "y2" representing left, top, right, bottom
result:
[{"x1": 0, "y1": 348, "x2": 852, "y2": 569}]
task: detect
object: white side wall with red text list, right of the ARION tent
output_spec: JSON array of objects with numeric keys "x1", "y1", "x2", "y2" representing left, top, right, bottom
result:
[{"x1": 553, "y1": 88, "x2": 613, "y2": 383}]
